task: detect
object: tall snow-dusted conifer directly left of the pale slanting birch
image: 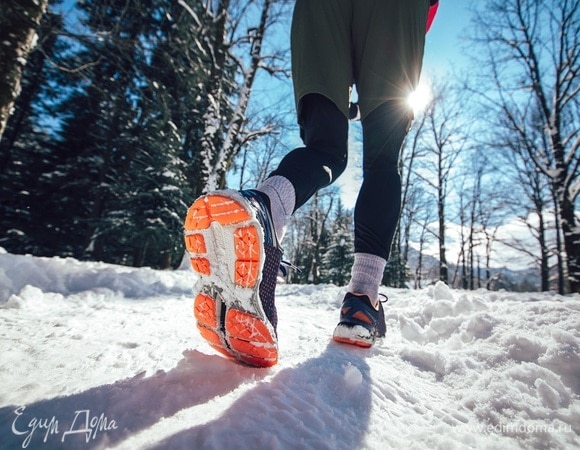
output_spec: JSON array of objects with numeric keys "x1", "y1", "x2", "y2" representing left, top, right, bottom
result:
[{"x1": 95, "y1": 2, "x2": 211, "y2": 268}]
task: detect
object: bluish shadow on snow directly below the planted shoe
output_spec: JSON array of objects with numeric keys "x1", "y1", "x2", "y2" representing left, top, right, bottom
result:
[{"x1": 154, "y1": 342, "x2": 372, "y2": 450}]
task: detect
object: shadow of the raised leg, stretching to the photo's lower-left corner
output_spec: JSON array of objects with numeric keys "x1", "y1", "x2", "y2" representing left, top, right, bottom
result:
[{"x1": 0, "y1": 350, "x2": 269, "y2": 450}]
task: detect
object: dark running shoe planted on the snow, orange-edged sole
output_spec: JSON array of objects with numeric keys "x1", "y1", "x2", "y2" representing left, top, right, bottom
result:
[{"x1": 332, "y1": 292, "x2": 387, "y2": 347}]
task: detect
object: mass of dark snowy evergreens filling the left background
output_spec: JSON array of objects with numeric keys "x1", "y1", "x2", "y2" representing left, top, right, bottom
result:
[{"x1": 0, "y1": 0, "x2": 285, "y2": 268}]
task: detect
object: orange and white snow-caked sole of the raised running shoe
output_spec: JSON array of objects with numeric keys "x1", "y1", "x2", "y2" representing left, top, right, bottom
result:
[{"x1": 185, "y1": 194, "x2": 278, "y2": 367}]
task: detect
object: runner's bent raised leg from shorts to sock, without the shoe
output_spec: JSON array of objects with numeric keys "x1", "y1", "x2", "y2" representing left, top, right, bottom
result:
[{"x1": 258, "y1": 0, "x2": 353, "y2": 243}]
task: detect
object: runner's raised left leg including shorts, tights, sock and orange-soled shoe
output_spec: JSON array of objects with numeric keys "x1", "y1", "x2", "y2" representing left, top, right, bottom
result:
[{"x1": 184, "y1": 0, "x2": 352, "y2": 367}]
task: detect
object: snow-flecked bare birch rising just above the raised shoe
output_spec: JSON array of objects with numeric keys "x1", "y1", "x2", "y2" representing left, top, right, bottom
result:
[{"x1": 198, "y1": 0, "x2": 292, "y2": 190}]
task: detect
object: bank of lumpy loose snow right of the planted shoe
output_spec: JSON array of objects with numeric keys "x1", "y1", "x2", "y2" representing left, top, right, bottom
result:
[{"x1": 388, "y1": 282, "x2": 580, "y2": 448}]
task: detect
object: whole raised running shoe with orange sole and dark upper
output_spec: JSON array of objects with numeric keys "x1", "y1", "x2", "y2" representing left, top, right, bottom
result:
[{"x1": 185, "y1": 191, "x2": 282, "y2": 367}]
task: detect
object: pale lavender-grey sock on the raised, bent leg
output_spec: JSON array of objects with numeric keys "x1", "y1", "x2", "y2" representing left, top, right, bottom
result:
[{"x1": 257, "y1": 175, "x2": 296, "y2": 242}]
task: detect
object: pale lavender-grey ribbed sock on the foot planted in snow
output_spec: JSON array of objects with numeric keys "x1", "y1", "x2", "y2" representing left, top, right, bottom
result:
[{"x1": 347, "y1": 253, "x2": 387, "y2": 307}]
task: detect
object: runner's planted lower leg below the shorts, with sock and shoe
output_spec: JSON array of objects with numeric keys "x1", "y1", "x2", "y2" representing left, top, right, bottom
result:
[{"x1": 333, "y1": 101, "x2": 410, "y2": 347}]
